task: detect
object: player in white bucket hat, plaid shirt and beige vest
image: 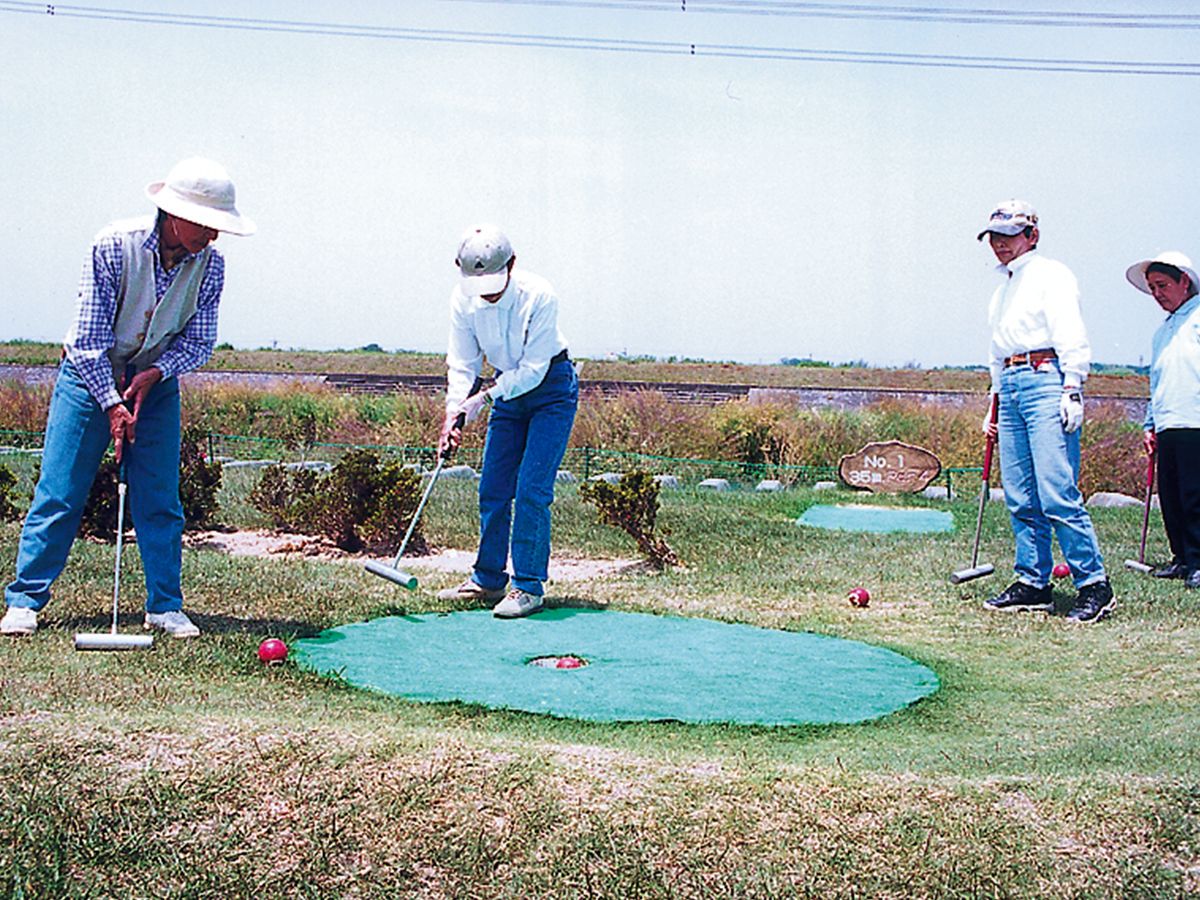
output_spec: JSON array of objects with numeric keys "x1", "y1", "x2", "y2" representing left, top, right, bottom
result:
[{"x1": 0, "y1": 158, "x2": 254, "y2": 637}]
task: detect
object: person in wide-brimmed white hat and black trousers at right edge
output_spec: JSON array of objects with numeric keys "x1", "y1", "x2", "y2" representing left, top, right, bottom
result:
[{"x1": 1126, "y1": 251, "x2": 1200, "y2": 590}]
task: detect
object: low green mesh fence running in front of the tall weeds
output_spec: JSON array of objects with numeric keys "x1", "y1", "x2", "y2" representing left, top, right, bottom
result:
[{"x1": 0, "y1": 431, "x2": 982, "y2": 494}]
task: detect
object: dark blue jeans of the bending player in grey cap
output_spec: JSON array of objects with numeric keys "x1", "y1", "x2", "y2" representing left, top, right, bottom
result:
[{"x1": 473, "y1": 360, "x2": 580, "y2": 596}]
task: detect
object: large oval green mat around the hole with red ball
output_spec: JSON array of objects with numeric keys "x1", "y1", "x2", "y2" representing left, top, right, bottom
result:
[{"x1": 293, "y1": 608, "x2": 938, "y2": 725}]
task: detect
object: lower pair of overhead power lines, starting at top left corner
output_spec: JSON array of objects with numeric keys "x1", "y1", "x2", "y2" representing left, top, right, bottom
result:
[{"x1": 0, "y1": 0, "x2": 1200, "y2": 77}]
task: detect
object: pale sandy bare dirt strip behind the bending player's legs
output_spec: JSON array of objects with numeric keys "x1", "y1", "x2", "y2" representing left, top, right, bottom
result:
[{"x1": 184, "y1": 530, "x2": 644, "y2": 582}]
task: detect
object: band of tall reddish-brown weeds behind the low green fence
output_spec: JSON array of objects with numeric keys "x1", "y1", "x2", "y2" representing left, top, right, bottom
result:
[{"x1": 0, "y1": 382, "x2": 1146, "y2": 497}]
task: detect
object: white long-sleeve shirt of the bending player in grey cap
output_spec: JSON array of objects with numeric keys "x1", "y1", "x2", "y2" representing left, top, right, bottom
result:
[{"x1": 446, "y1": 269, "x2": 566, "y2": 409}]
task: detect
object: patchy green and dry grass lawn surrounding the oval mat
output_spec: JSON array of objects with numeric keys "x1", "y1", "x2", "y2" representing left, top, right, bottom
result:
[{"x1": 0, "y1": 480, "x2": 1200, "y2": 899}]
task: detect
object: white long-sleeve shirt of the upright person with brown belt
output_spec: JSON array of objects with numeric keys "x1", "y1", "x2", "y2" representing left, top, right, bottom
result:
[{"x1": 988, "y1": 250, "x2": 1092, "y2": 392}]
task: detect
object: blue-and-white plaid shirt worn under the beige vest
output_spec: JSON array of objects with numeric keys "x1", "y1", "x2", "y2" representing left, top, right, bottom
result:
[{"x1": 66, "y1": 217, "x2": 224, "y2": 409}]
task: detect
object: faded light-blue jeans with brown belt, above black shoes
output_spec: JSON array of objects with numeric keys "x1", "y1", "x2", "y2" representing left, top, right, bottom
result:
[{"x1": 998, "y1": 362, "x2": 1106, "y2": 588}]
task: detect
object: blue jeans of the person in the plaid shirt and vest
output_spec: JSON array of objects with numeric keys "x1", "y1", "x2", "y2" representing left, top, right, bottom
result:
[{"x1": 4, "y1": 362, "x2": 184, "y2": 613}]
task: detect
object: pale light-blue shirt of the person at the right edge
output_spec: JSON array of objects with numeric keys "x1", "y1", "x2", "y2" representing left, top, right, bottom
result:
[{"x1": 1145, "y1": 296, "x2": 1200, "y2": 431}]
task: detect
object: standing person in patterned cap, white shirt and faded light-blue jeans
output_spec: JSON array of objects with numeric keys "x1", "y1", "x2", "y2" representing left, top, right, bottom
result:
[{"x1": 978, "y1": 200, "x2": 1116, "y2": 624}]
